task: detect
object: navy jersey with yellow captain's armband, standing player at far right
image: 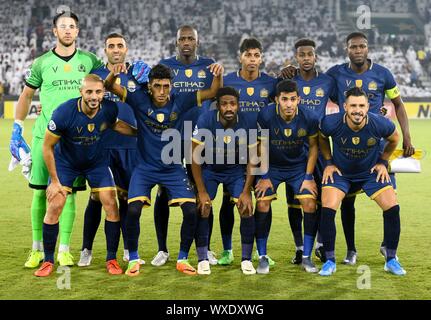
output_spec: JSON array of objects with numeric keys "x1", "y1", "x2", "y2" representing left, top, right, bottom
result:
[{"x1": 326, "y1": 60, "x2": 400, "y2": 113}]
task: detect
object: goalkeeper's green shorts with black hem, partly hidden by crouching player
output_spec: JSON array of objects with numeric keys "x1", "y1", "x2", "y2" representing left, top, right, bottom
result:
[{"x1": 28, "y1": 137, "x2": 86, "y2": 191}]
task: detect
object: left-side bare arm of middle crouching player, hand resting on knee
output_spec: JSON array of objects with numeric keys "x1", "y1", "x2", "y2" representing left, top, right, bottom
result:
[{"x1": 192, "y1": 141, "x2": 211, "y2": 218}]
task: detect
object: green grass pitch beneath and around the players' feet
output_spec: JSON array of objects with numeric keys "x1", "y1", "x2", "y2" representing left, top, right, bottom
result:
[{"x1": 0, "y1": 120, "x2": 431, "y2": 300}]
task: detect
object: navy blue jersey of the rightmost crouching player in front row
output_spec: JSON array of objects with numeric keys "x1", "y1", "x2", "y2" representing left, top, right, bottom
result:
[{"x1": 320, "y1": 113, "x2": 395, "y2": 179}]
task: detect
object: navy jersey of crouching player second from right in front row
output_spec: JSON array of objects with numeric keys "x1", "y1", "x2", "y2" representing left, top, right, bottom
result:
[{"x1": 257, "y1": 103, "x2": 319, "y2": 170}]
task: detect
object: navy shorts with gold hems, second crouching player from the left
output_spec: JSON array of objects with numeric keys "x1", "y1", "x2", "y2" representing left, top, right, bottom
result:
[{"x1": 128, "y1": 164, "x2": 196, "y2": 207}]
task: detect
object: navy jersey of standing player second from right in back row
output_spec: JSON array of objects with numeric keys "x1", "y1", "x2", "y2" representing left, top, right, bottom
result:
[{"x1": 292, "y1": 73, "x2": 336, "y2": 120}]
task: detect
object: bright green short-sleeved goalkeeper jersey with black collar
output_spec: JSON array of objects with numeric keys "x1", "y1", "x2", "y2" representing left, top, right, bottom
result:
[{"x1": 25, "y1": 49, "x2": 103, "y2": 138}]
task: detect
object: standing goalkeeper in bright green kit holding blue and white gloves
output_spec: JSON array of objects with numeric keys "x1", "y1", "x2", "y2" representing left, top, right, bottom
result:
[{"x1": 10, "y1": 11, "x2": 103, "y2": 268}]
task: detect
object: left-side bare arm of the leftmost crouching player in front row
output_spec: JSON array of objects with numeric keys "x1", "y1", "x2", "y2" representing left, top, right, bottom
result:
[{"x1": 42, "y1": 132, "x2": 67, "y2": 202}]
